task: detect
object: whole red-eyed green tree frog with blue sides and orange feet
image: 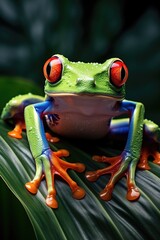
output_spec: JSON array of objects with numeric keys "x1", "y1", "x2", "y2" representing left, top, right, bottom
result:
[{"x1": 1, "y1": 54, "x2": 160, "y2": 209}]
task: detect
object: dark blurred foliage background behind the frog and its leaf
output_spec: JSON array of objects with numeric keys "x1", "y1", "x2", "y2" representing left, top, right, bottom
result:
[{"x1": 0, "y1": 0, "x2": 160, "y2": 239}]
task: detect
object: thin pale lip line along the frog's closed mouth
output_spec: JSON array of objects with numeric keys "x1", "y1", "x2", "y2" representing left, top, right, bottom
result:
[{"x1": 45, "y1": 91, "x2": 124, "y2": 101}]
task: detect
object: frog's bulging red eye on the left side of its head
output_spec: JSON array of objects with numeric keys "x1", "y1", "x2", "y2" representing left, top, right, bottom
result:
[{"x1": 43, "y1": 56, "x2": 62, "y2": 83}]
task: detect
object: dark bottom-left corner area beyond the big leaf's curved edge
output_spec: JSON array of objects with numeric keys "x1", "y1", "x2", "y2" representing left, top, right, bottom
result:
[{"x1": 0, "y1": 178, "x2": 36, "y2": 240}]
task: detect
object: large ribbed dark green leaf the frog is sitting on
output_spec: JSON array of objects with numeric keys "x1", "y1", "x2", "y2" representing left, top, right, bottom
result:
[{"x1": 0, "y1": 122, "x2": 160, "y2": 240}]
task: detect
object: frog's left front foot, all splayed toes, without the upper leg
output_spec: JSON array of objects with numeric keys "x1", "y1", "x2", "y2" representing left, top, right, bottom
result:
[{"x1": 25, "y1": 149, "x2": 85, "y2": 208}]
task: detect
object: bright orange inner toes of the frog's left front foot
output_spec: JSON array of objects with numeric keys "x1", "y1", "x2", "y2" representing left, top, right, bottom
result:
[{"x1": 51, "y1": 149, "x2": 85, "y2": 202}]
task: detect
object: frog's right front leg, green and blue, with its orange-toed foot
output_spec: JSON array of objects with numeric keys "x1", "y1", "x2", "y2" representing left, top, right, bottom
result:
[{"x1": 86, "y1": 100, "x2": 144, "y2": 201}]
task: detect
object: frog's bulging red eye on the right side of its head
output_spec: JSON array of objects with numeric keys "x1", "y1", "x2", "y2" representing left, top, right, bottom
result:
[{"x1": 110, "y1": 60, "x2": 128, "y2": 87}]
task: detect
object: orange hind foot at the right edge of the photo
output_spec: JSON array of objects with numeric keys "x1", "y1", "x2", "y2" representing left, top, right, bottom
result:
[{"x1": 138, "y1": 144, "x2": 160, "y2": 170}]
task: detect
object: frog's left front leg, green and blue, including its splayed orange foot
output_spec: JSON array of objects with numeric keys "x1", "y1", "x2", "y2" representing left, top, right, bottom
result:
[{"x1": 25, "y1": 100, "x2": 85, "y2": 208}]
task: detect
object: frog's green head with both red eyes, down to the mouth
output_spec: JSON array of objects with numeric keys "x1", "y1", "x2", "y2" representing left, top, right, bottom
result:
[{"x1": 43, "y1": 54, "x2": 128, "y2": 100}]
